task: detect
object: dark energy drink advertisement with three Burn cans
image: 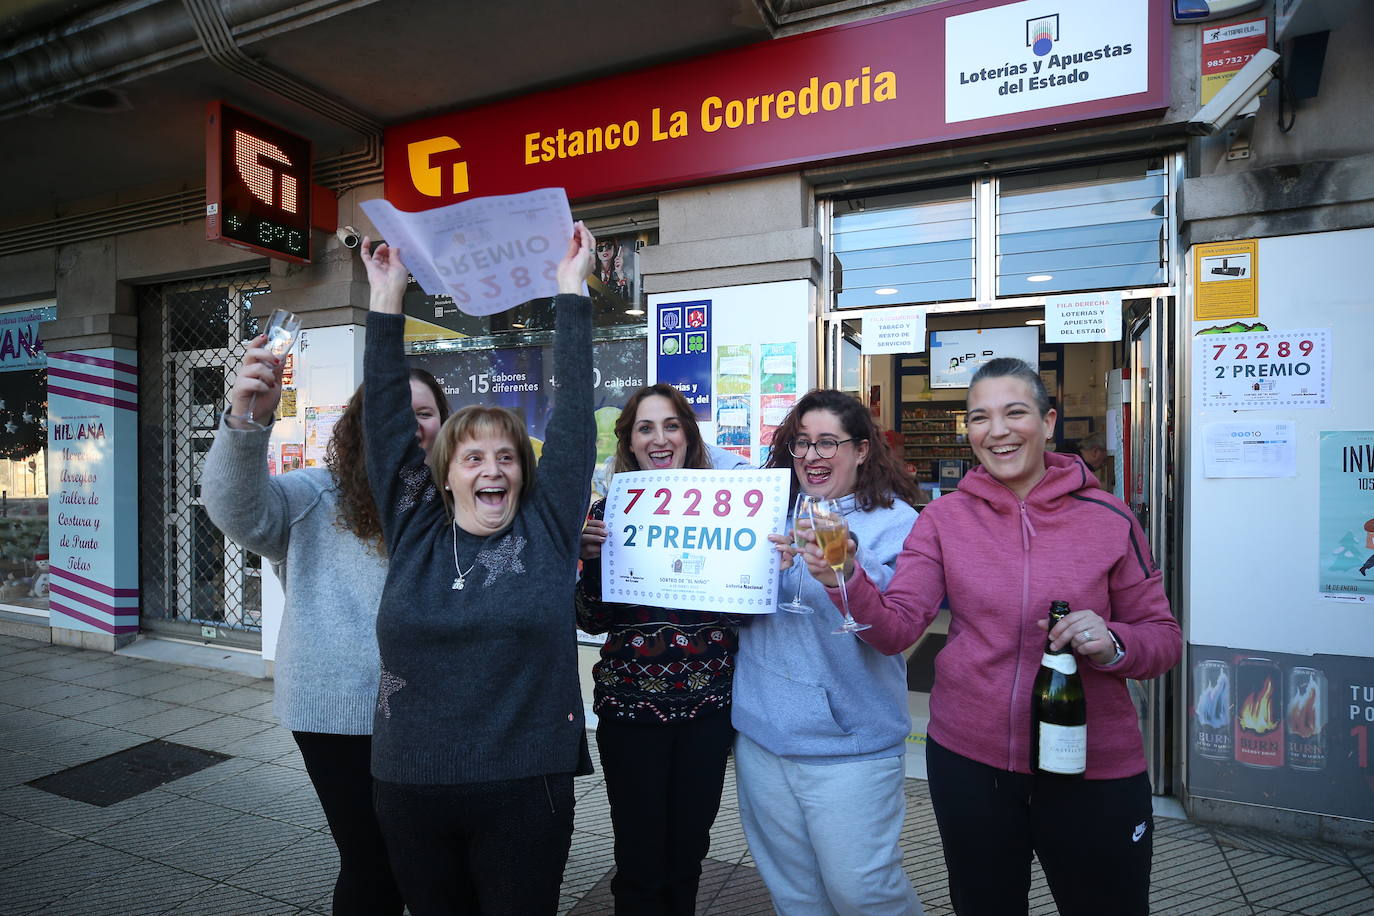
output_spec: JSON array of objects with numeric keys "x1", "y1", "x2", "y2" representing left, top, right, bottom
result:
[{"x1": 1189, "y1": 645, "x2": 1374, "y2": 820}]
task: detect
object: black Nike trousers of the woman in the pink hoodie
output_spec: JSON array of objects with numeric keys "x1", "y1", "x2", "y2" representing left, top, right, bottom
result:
[{"x1": 926, "y1": 739, "x2": 1154, "y2": 916}]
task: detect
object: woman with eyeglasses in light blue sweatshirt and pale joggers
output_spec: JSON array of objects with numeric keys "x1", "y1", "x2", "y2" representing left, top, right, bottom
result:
[{"x1": 732, "y1": 390, "x2": 922, "y2": 916}]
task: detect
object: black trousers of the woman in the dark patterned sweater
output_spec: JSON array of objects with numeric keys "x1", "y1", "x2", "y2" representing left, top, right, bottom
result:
[{"x1": 596, "y1": 710, "x2": 735, "y2": 916}]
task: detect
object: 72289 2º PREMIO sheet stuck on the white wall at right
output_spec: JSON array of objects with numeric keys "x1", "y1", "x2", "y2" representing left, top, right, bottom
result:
[{"x1": 1193, "y1": 328, "x2": 1331, "y2": 411}]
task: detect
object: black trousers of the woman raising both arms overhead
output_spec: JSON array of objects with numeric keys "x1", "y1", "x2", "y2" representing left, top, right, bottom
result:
[{"x1": 374, "y1": 773, "x2": 573, "y2": 916}]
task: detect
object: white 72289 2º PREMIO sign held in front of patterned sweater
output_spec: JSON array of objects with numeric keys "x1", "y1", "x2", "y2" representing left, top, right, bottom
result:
[{"x1": 602, "y1": 468, "x2": 791, "y2": 614}]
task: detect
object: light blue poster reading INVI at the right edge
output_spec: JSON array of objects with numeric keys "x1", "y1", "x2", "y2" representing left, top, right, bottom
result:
[{"x1": 1316, "y1": 430, "x2": 1374, "y2": 611}]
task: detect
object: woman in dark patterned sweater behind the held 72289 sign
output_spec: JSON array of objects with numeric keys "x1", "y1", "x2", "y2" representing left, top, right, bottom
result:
[{"x1": 576, "y1": 385, "x2": 739, "y2": 915}]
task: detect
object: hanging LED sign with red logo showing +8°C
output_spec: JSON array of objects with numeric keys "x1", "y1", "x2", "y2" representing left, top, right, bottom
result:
[{"x1": 205, "y1": 102, "x2": 311, "y2": 264}]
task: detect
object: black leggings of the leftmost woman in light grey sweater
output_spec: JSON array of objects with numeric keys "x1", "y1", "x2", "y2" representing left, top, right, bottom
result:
[{"x1": 291, "y1": 732, "x2": 401, "y2": 916}]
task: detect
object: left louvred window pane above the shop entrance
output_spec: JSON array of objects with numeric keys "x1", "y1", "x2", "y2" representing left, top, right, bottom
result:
[{"x1": 831, "y1": 184, "x2": 976, "y2": 309}]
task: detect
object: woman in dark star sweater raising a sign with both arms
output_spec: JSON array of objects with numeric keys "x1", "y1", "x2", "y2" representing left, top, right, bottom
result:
[{"x1": 361, "y1": 224, "x2": 596, "y2": 916}]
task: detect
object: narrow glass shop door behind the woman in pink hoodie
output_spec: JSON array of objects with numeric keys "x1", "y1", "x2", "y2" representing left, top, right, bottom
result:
[{"x1": 1120, "y1": 297, "x2": 1180, "y2": 795}]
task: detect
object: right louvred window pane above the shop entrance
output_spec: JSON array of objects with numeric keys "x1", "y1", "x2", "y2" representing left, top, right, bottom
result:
[{"x1": 998, "y1": 159, "x2": 1169, "y2": 297}]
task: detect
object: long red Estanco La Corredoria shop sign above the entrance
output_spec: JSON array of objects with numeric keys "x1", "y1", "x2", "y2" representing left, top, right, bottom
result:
[{"x1": 385, "y1": 0, "x2": 1169, "y2": 210}]
